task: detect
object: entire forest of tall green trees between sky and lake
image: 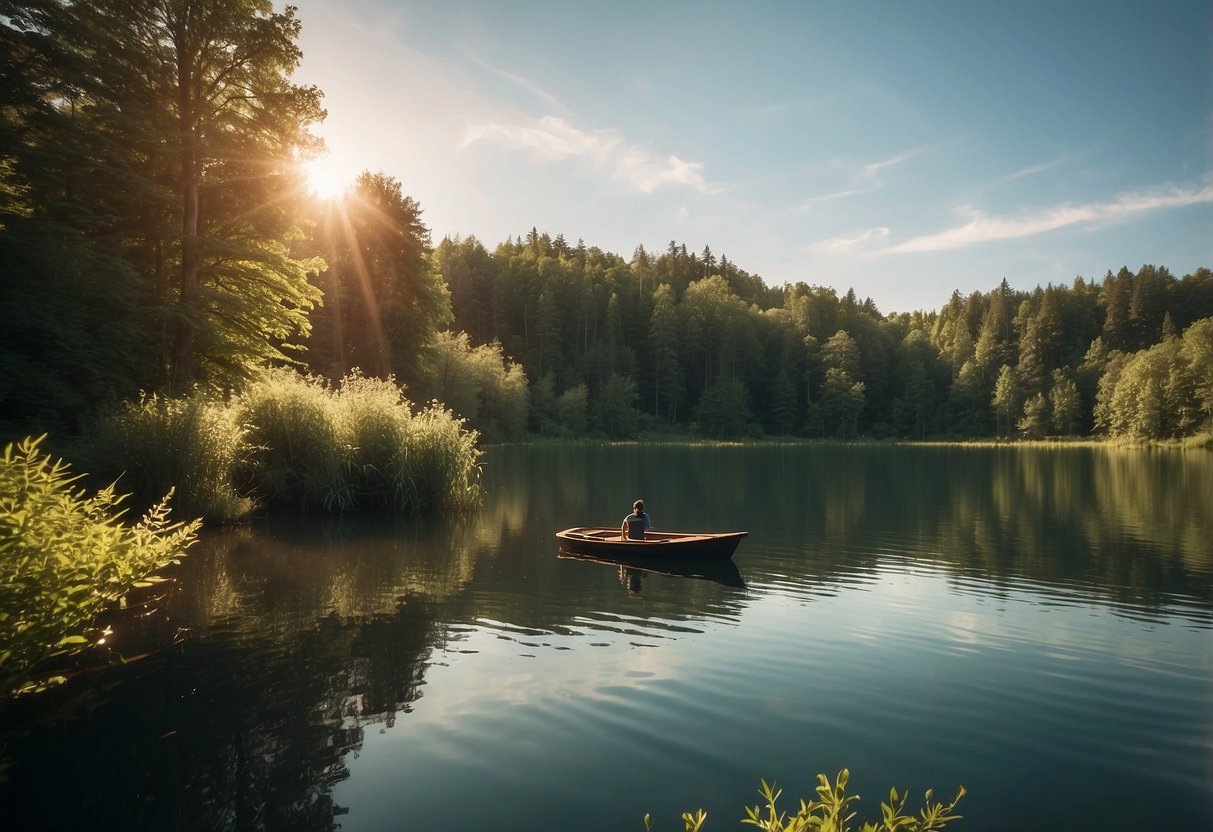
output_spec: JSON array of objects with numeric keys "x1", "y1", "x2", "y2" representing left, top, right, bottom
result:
[{"x1": 0, "y1": 0, "x2": 1213, "y2": 448}]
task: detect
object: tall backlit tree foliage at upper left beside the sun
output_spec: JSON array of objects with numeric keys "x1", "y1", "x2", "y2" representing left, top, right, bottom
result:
[{"x1": 0, "y1": 0, "x2": 323, "y2": 405}]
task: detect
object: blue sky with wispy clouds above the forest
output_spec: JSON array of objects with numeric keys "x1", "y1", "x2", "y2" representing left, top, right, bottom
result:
[{"x1": 294, "y1": 0, "x2": 1213, "y2": 312}]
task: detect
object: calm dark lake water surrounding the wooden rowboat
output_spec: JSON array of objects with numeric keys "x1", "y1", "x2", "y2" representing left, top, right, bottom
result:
[{"x1": 0, "y1": 445, "x2": 1213, "y2": 832}]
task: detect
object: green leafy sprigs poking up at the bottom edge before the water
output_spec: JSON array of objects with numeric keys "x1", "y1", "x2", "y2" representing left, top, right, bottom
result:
[{"x1": 644, "y1": 769, "x2": 966, "y2": 832}]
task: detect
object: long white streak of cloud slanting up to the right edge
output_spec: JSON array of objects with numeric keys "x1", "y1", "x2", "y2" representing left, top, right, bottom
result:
[{"x1": 876, "y1": 177, "x2": 1213, "y2": 255}]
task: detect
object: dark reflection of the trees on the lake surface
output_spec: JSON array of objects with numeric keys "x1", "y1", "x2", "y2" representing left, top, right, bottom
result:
[{"x1": 0, "y1": 445, "x2": 1213, "y2": 830}]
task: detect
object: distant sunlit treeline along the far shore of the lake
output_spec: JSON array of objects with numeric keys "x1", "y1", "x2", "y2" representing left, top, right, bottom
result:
[{"x1": 434, "y1": 229, "x2": 1213, "y2": 439}]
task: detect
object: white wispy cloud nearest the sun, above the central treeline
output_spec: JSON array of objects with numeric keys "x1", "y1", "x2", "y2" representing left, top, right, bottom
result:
[{"x1": 460, "y1": 116, "x2": 722, "y2": 193}]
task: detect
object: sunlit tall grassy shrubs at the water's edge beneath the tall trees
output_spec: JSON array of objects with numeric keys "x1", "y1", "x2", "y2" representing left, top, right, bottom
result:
[{"x1": 93, "y1": 370, "x2": 480, "y2": 522}]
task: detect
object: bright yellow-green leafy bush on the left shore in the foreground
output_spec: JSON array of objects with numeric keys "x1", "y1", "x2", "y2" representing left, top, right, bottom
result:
[{"x1": 0, "y1": 437, "x2": 198, "y2": 699}]
